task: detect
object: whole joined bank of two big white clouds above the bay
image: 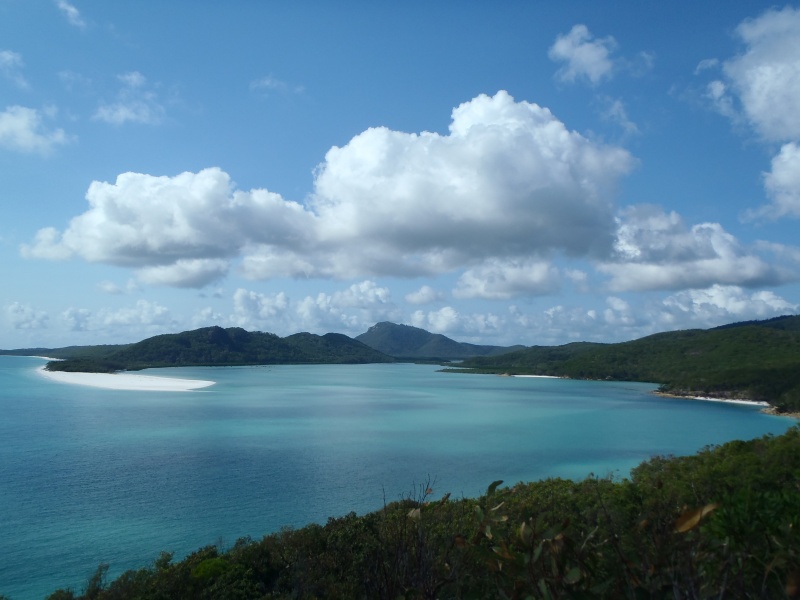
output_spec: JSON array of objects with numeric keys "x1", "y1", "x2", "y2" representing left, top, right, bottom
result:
[{"x1": 22, "y1": 93, "x2": 635, "y2": 289}]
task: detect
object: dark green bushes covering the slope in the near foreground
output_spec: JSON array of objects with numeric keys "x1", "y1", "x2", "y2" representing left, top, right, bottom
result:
[{"x1": 40, "y1": 427, "x2": 800, "y2": 600}]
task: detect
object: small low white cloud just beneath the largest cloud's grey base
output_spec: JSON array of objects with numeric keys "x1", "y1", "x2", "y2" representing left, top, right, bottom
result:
[{"x1": 453, "y1": 258, "x2": 561, "y2": 300}]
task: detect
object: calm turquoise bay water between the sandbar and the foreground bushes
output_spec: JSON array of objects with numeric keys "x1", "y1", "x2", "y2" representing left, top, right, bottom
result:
[{"x1": 0, "y1": 356, "x2": 795, "y2": 600}]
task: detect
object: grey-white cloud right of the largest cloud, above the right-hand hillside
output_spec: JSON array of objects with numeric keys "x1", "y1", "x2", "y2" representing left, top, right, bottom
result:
[{"x1": 598, "y1": 205, "x2": 789, "y2": 291}]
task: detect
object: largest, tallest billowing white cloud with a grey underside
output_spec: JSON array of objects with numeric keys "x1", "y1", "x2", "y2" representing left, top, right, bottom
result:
[{"x1": 312, "y1": 92, "x2": 634, "y2": 276}]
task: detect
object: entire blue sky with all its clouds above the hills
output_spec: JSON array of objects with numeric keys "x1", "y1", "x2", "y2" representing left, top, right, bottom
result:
[{"x1": 0, "y1": 0, "x2": 800, "y2": 349}]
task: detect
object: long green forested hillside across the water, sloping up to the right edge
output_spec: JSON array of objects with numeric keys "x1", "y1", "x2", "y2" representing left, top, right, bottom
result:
[{"x1": 450, "y1": 316, "x2": 800, "y2": 411}]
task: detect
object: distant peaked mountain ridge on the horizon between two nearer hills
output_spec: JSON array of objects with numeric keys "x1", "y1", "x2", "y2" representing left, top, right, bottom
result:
[{"x1": 355, "y1": 321, "x2": 525, "y2": 360}]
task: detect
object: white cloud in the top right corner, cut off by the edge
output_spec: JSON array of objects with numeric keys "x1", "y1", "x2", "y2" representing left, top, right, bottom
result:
[{"x1": 709, "y1": 6, "x2": 800, "y2": 142}]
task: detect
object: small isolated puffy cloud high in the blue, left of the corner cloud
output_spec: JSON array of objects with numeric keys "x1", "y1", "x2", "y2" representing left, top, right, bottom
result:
[{"x1": 548, "y1": 25, "x2": 617, "y2": 85}]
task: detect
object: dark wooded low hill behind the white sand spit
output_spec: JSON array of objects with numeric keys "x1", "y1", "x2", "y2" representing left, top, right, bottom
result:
[{"x1": 40, "y1": 327, "x2": 394, "y2": 372}]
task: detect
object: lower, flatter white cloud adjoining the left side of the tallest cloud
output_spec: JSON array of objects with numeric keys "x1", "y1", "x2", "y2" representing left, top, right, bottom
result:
[{"x1": 22, "y1": 169, "x2": 313, "y2": 287}]
